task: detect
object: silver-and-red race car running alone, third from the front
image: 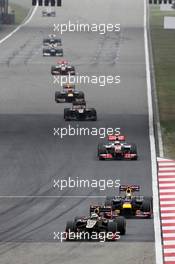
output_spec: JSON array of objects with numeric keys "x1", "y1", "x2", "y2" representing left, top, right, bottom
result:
[{"x1": 97, "y1": 141, "x2": 138, "y2": 160}]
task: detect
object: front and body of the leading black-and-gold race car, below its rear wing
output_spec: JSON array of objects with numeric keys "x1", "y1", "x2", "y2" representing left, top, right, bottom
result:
[{"x1": 65, "y1": 208, "x2": 123, "y2": 240}]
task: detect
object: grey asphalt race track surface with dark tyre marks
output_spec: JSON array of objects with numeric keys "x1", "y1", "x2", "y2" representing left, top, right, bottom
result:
[{"x1": 0, "y1": 0, "x2": 155, "y2": 264}]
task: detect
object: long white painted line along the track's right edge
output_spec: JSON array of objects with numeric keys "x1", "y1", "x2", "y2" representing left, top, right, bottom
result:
[{"x1": 144, "y1": 0, "x2": 163, "y2": 264}]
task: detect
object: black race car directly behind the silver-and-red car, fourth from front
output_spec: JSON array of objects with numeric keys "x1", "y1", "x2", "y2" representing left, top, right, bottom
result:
[{"x1": 64, "y1": 101, "x2": 97, "y2": 121}]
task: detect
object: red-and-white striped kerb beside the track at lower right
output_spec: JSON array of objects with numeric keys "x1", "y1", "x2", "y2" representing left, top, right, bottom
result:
[{"x1": 158, "y1": 158, "x2": 175, "y2": 264}]
